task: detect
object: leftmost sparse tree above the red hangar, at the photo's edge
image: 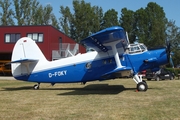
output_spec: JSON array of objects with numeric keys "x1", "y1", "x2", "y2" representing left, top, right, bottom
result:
[{"x1": 0, "y1": 0, "x2": 14, "y2": 26}]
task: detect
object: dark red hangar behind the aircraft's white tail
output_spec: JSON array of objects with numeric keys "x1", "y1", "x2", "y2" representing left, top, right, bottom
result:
[{"x1": 0, "y1": 25, "x2": 85, "y2": 75}]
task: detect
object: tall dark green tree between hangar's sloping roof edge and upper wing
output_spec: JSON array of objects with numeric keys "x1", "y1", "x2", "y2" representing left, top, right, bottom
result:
[{"x1": 71, "y1": 0, "x2": 94, "y2": 42}]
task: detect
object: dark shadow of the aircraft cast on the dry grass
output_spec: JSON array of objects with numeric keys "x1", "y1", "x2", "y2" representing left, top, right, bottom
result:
[{"x1": 1, "y1": 84, "x2": 141, "y2": 95}]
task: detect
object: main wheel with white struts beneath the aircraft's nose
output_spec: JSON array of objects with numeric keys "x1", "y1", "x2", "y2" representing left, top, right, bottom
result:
[{"x1": 133, "y1": 74, "x2": 148, "y2": 91}]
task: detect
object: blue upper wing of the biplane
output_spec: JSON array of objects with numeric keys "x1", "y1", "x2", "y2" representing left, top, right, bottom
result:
[{"x1": 81, "y1": 26, "x2": 128, "y2": 52}]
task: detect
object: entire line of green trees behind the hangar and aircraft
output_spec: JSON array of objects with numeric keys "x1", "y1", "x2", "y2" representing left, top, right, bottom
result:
[{"x1": 0, "y1": 0, "x2": 180, "y2": 65}]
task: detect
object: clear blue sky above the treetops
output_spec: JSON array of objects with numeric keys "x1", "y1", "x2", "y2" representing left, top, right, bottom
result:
[{"x1": 38, "y1": 0, "x2": 180, "y2": 27}]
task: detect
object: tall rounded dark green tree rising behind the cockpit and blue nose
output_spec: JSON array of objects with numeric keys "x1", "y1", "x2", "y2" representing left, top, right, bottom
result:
[{"x1": 142, "y1": 2, "x2": 167, "y2": 47}]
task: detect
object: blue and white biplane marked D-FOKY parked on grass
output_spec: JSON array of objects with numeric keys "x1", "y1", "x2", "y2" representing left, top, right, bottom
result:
[{"x1": 11, "y1": 26, "x2": 170, "y2": 91}]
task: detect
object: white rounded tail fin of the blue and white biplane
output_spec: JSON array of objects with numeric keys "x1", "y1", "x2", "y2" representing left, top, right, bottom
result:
[{"x1": 11, "y1": 37, "x2": 47, "y2": 76}]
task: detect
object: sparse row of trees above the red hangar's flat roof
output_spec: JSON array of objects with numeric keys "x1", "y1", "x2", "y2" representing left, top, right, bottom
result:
[{"x1": 0, "y1": 0, "x2": 59, "y2": 29}]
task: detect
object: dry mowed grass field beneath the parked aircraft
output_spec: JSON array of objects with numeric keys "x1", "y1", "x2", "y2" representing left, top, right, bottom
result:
[{"x1": 0, "y1": 79, "x2": 180, "y2": 120}]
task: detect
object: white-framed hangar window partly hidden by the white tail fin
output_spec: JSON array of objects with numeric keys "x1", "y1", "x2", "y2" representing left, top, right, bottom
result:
[{"x1": 27, "y1": 33, "x2": 43, "y2": 42}]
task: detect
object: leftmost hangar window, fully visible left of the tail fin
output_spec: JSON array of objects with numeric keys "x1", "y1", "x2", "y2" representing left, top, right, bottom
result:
[{"x1": 5, "y1": 33, "x2": 21, "y2": 43}]
